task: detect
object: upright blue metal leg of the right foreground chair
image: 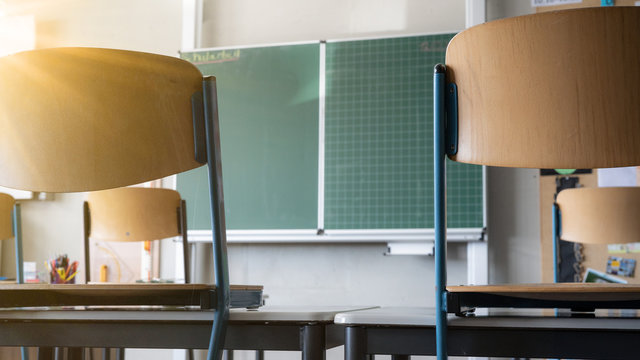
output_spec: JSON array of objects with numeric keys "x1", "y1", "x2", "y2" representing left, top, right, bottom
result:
[{"x1": 433, "y1": 64, "x2": 447, "y2": 360}]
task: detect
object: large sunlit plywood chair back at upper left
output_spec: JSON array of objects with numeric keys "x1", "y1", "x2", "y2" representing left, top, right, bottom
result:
[{"x1": 0, "y1": 48, "x2": 202, "y2": 192}]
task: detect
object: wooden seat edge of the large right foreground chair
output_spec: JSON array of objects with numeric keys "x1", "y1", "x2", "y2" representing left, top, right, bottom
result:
[{"x1": 447, "y1": 283, "x2": 640, "y2": 314}]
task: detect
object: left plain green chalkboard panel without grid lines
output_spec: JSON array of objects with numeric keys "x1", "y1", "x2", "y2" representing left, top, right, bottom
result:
[{"x1": 177, "y1": 42, "x2": 320, "y2": 230}]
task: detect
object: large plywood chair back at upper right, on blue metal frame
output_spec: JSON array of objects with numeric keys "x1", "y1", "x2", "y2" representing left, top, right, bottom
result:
[{"x1": 446, "y1": 7, "x2": 640, "y2": 168}]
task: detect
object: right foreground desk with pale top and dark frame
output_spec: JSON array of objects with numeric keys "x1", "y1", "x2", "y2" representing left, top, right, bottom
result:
[{"x1": 335, "y1": 308, "x2": 640, "y2": 360}]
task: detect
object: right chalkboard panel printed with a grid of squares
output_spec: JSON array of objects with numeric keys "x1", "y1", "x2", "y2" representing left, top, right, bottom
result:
[{"x1": 324, "y1": 34, "x2": 483, "y2": 229}]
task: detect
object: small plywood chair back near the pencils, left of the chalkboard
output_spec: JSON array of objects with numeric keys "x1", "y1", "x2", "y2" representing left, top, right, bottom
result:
[{"x1": 87, "y1": 187, "x2": 181, "y2": 241}]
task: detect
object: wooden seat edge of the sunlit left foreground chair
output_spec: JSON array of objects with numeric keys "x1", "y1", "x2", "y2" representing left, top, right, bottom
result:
[{"x1": 0, "y1": 283, "x2": 262, "y2": 309}]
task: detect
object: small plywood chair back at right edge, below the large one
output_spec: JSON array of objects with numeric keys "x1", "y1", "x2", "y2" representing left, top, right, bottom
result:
[{"x1": 556, "y1": 187, "x2": 640, "y2": 244}]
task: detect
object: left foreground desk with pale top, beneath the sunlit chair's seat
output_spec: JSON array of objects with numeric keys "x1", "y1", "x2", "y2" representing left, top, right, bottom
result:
[{"x1": 0, "y1": 307, "x2": 370, "y2": 360}]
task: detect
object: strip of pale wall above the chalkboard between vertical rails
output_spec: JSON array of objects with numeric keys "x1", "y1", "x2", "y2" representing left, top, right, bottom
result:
[{"x1": 202, "y1": 0, "x2": 464, "y2": 48}]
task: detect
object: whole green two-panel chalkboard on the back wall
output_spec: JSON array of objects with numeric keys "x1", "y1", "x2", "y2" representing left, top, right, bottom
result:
[{"x1": 178, "y1": 34, "x2": 484, "y2": 231}]
